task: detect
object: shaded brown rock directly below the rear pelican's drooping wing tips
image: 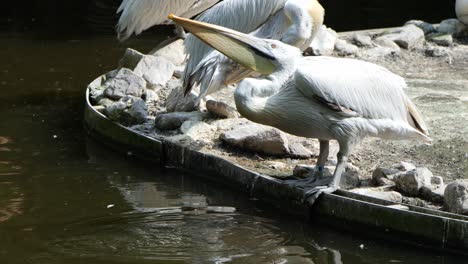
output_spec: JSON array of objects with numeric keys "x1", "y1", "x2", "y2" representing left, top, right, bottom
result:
[{"x1": 166, "y1": 86, "x2": 199, "y2": 112}]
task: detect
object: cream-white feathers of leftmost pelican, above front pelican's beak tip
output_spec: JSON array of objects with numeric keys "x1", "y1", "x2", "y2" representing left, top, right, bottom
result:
[{"x1": 117, "y1": 0, "x2": 220, "y2": 40}]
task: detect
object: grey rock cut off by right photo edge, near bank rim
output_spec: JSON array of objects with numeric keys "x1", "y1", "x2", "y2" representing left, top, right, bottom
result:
[{"x1": 444, "y1": 180, "x2": 468, "y2": 215}]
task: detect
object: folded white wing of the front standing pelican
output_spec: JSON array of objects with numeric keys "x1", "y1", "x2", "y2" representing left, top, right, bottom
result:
[{"x1": 294, "y1": 57, "x2": 414, "y2": 122}]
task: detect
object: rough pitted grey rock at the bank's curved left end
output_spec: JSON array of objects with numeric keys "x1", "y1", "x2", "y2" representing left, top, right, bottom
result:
[{"x1": 103, "y1": 68, "x2": 146, "y2": 100}]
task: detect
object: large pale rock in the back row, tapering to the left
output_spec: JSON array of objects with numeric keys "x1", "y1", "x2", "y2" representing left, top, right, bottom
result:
[{"x1": 385, "y1": 24, "x2": 426, "y2": 50}]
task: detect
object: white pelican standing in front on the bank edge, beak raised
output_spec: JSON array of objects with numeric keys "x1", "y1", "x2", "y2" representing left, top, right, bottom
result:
[{"x1": 170, "y1": 15, "x2": 432, "y2": 196}]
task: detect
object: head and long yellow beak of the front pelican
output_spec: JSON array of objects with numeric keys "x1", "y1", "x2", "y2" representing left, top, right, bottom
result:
[{"x1": 169, "y1": 15, "x2": 301, "y2": 75}]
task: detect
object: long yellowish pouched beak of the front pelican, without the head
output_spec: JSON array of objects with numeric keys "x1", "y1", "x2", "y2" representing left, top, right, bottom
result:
[{"x1": 169, "y1": 14, "x2": 276, "y2": 74}]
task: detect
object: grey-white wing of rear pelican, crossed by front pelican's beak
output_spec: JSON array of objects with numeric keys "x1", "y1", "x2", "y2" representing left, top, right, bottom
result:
[{"x1": 184, "y1": 0, "x2": 288, "y2": 90}]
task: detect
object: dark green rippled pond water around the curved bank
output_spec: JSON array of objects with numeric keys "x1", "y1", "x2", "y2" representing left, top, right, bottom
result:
[{"x1": 0, "y1": 35, "x2": 465, "y2": 264}]
